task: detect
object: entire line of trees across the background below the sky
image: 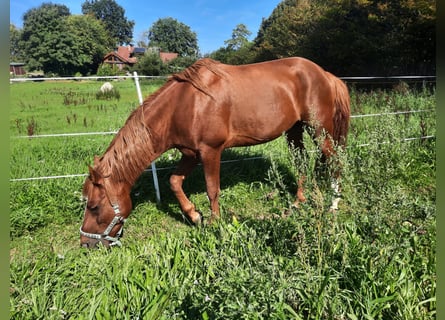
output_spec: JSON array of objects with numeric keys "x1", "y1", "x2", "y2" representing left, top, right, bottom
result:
[{"x1": 10, "y1": 0, "x2": 436, "y2": 76}]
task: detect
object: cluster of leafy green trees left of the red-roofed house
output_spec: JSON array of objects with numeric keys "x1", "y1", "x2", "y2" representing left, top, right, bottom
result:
[{"x1": 10, "y1": 0, "x2": 134, "y2": 75}]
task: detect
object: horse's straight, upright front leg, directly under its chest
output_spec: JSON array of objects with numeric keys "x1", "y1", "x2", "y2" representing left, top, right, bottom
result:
[{"x1": 201, "y1": 147, "x2": 222, "y2": 223}]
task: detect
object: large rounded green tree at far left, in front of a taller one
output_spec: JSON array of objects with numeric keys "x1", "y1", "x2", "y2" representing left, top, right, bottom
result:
[{"x1": 19, "y1": 3, "x2": 113, "y2": 75}]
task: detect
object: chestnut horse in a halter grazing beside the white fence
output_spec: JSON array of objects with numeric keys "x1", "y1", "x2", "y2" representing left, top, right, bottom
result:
[{"x1": 80, "y1": 58, "x2": 350, "y2": 247}]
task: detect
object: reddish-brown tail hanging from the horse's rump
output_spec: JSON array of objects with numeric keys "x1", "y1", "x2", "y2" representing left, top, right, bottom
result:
[{"x1": 328, "y1": 72, "x2": 351, "y2": 146}]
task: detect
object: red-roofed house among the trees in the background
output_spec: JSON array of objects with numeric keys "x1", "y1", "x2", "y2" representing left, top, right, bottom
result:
[{"x1": 102, "y1": 45, "x2": 178, "y2": 70}]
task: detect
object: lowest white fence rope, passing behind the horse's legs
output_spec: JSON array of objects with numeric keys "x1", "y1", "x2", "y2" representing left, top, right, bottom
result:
[{"x1": 9, "y1": 135, "x2": 435, "y2": 182}]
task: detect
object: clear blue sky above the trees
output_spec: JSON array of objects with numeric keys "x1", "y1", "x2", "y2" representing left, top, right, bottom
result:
[{"x1": 9, "y1": 0, "x2": 281, "y2": 54}]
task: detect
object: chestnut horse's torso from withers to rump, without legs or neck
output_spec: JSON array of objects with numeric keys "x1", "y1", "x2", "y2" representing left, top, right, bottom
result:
[{"x1": 172, "y1": 57, "x2": 346, "y2": 147}]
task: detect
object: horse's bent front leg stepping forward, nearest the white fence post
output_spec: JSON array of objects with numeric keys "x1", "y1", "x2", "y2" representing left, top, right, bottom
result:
[{"x1": 170, "y1": 153, "x2": 202, "y2": 224}]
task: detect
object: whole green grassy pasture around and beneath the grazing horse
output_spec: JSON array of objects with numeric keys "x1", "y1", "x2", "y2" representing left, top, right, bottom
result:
[{"x1": 10, "y1": 80, "x2": 436, "y2": 319}]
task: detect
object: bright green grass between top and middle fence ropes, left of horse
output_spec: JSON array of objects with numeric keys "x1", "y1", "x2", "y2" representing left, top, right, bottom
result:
[{"x1": 10, "y1": 79, "x2": 164, "y2": 136}]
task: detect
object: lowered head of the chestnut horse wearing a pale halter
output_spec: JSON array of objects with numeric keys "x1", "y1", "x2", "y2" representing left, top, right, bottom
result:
[{"x1": 80, "y1": 162, "x2": 132, "y2": 248}]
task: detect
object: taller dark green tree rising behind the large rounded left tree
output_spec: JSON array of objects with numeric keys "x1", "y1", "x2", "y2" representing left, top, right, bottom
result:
[{"x1": 82, "y1": 0, "x2": 134, "y2": 45}]
